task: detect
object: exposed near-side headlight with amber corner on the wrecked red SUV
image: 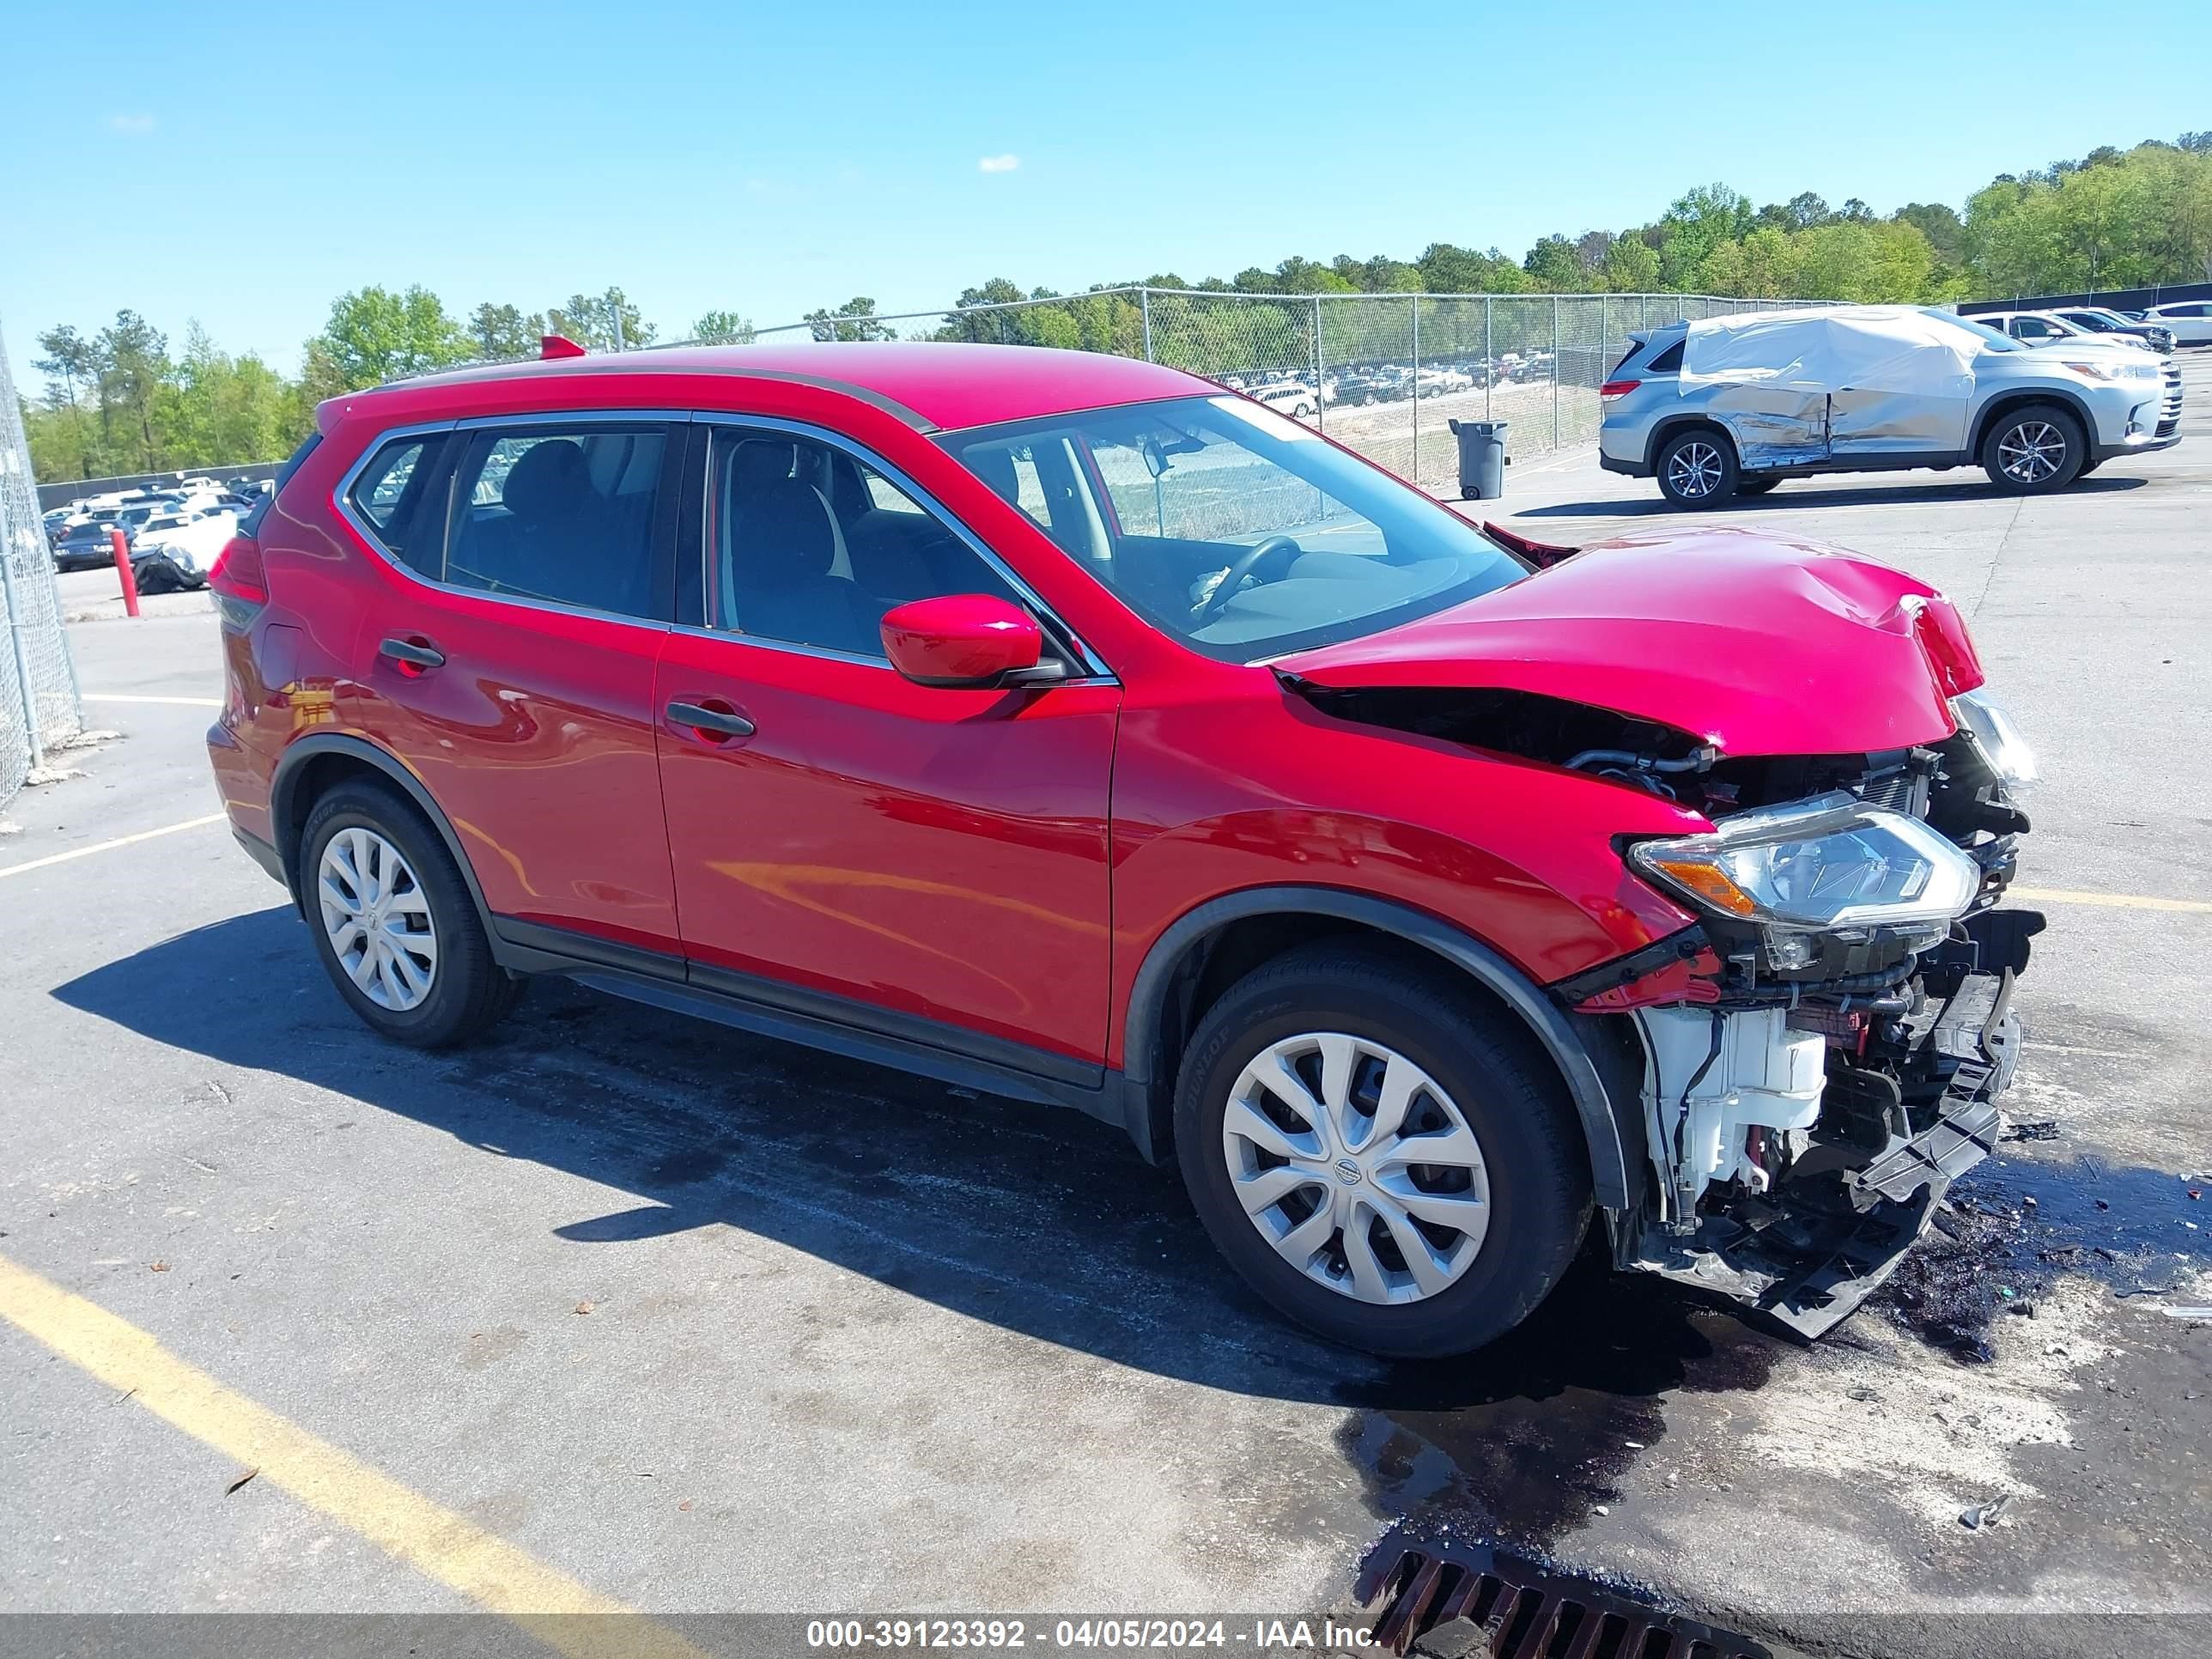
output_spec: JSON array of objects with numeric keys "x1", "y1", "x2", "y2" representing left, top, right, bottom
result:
[{"x1": 1628, "y1": 790, "x2": 1982, "y2": 933}]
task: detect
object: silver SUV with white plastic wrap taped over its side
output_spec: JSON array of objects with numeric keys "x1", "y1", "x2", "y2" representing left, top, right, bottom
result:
[{"x1": 1597, "y1": 305, "x2": 2181, "y2": 507}]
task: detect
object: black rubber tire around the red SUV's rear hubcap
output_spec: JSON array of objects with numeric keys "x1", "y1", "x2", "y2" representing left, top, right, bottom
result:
[{"x1": 299, "y1": 779, "x2": 525, "y2": 1048}]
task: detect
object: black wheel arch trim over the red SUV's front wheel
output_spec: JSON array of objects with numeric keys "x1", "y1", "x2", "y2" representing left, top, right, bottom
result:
[{"x1": 1121, "y1": 887, "x2": 1641, "y2": 1210}]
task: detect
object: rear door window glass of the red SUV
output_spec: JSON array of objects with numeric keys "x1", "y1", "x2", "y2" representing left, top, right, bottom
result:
[{"x1": 445, "y1": 422, "x2": 675, "y2": 619}]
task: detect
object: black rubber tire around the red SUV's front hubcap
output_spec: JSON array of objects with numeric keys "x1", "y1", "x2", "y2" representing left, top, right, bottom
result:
[{"x1": 1175, "y1": 945, "x2": 1590, "y2": 1358}]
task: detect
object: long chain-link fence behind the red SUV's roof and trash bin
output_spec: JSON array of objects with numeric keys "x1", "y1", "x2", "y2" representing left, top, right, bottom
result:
[{"x1": 754, "y1": 288, "x2": 1809, "y2": 489}]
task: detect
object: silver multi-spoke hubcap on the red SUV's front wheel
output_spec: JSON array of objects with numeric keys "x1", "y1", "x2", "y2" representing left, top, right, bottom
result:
[{"x1": 1221, "y1": 1030, "x2": 1491, "y2": 1303}]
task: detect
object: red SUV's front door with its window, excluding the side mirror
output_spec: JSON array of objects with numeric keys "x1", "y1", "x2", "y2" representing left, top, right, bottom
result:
[{"x1": 657, "y1": 425, "x2": 1119, "y2": 1082}]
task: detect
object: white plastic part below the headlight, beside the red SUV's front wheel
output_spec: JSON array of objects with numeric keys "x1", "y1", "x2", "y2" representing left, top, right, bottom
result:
[{"x1": 1637, "y1": 1006, "x2": 1827, "y2": 1214}]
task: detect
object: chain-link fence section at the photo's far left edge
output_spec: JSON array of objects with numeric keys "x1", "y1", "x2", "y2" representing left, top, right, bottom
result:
[{"x1": 0, "y1": 316, "x2": 84, "y2": 805}]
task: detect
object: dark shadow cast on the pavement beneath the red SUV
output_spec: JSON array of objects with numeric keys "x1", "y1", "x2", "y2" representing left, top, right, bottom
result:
[{"x1": 53, "y1": 905, "x2": 1783, "y2": 1547}]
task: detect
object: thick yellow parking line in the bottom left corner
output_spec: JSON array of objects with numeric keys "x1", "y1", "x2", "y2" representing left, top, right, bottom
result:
[{"x1": 0, "y1": 1256, "x2": 706, "y2": 1659}]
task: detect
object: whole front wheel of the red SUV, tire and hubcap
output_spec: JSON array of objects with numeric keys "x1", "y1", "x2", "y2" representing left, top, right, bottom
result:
[{"x1": 1175, "y1": 945, "x2": 1590, "y2": 1358}]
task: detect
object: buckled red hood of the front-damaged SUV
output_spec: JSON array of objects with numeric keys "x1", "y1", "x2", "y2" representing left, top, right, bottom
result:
[{"x1": 1276, "y1": 529, "x2": 1982, "y2": 754}]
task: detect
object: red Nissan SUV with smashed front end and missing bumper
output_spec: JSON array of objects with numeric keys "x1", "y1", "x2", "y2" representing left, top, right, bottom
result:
[{"x1": 208, "y1": 343, "x2": 2042, "y2": 1356}]
